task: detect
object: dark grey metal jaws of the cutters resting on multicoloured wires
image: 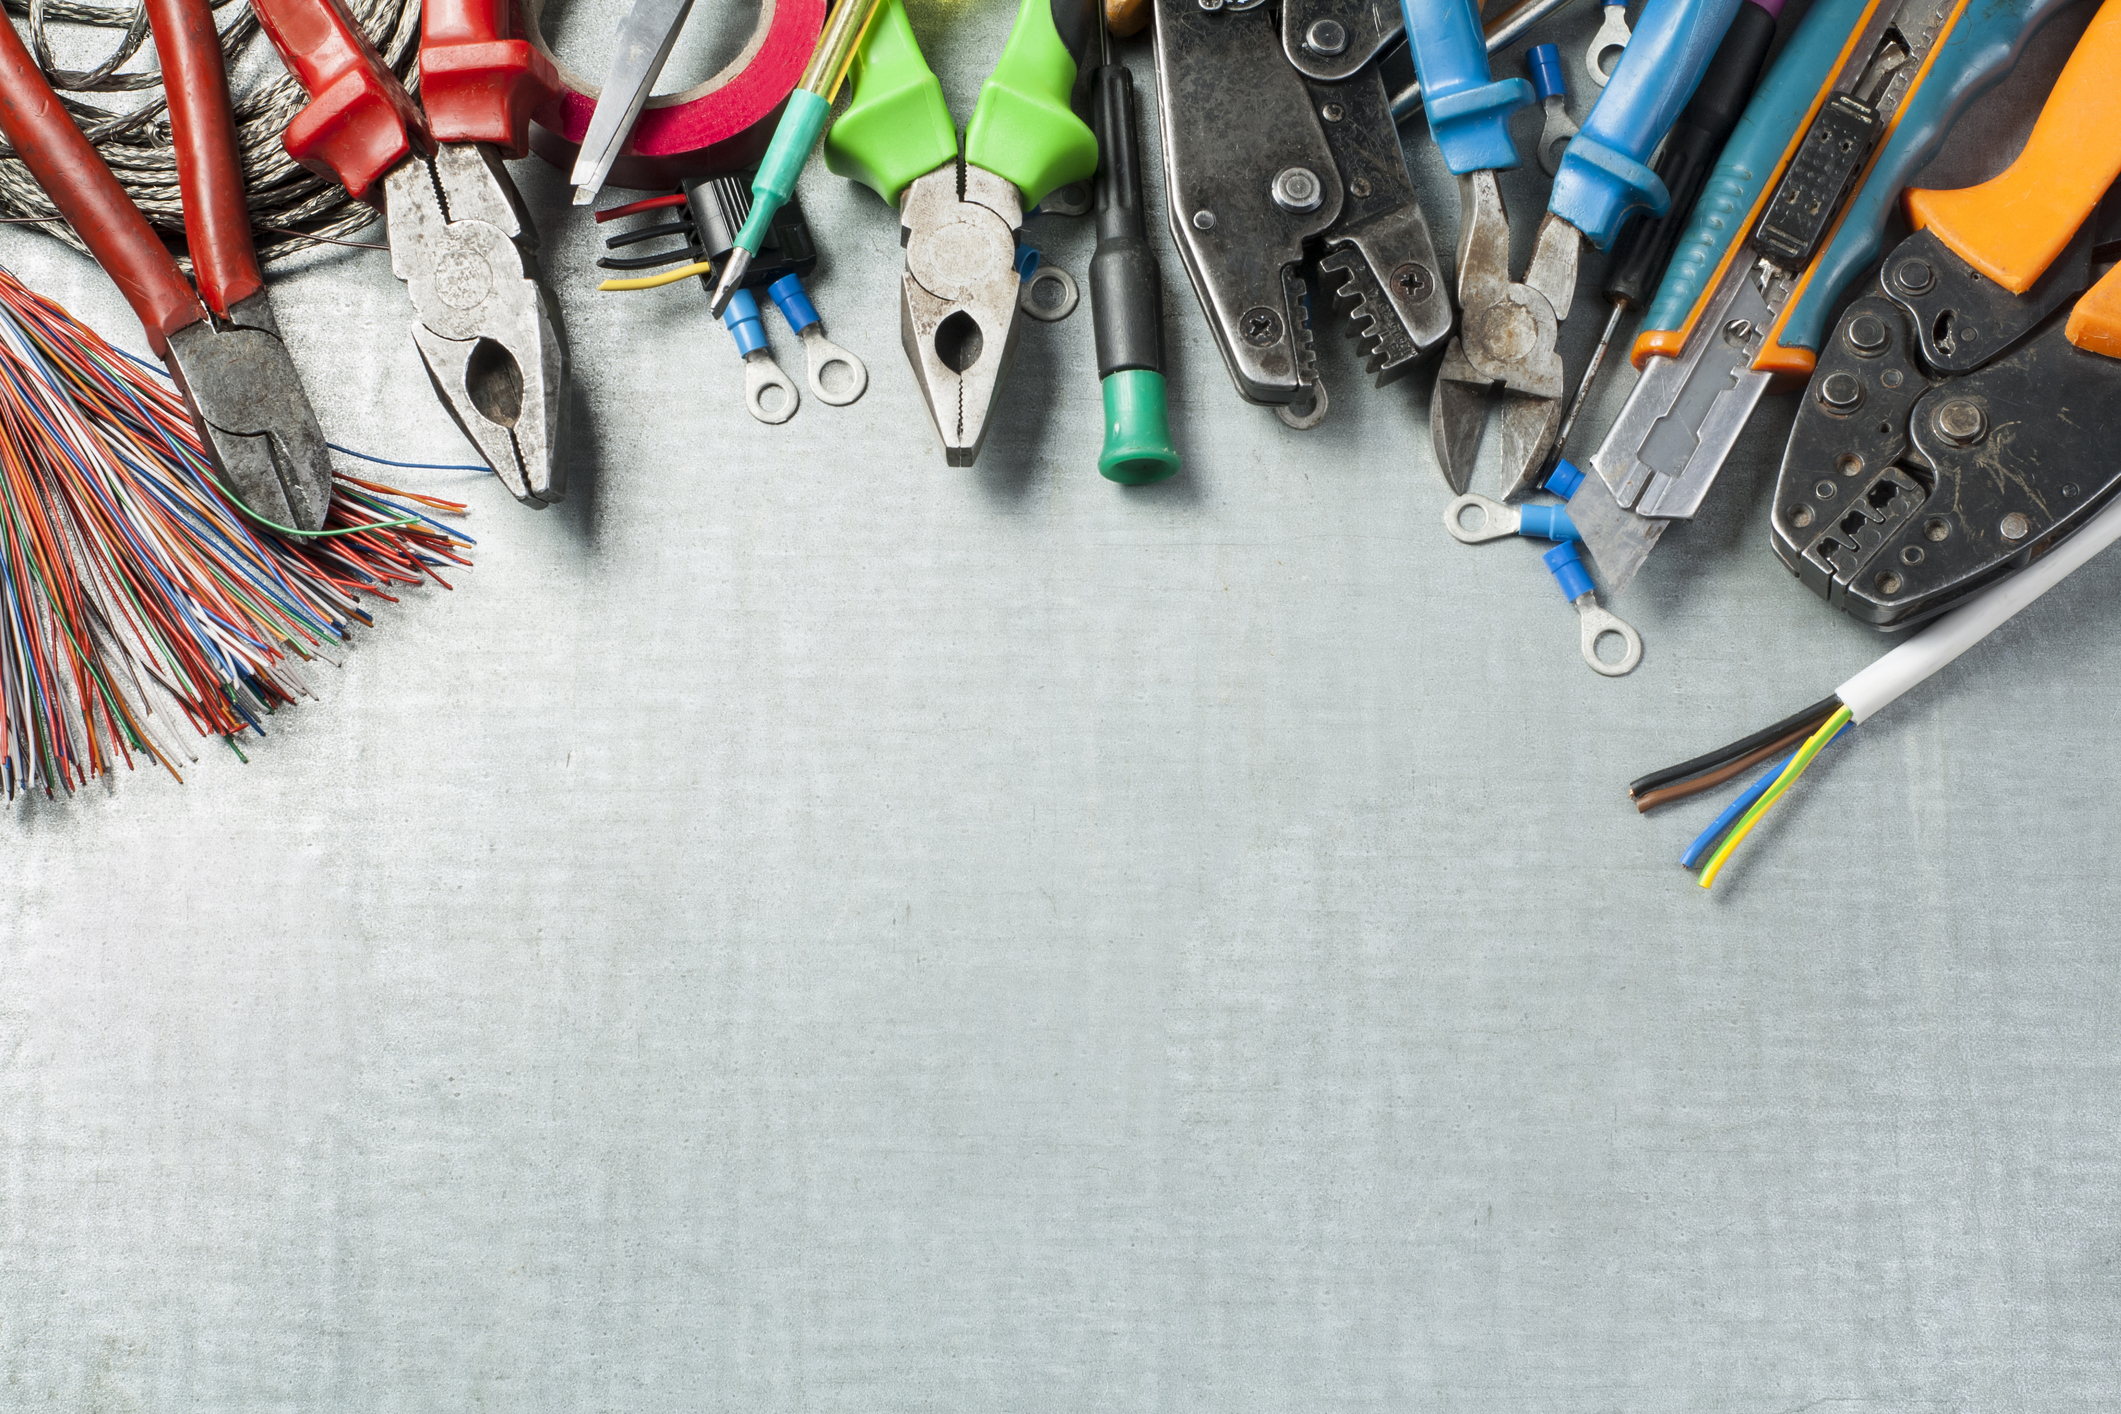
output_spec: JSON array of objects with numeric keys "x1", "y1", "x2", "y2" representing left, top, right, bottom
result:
[{"x1": 168, "y1": 290, "x2": 331, "y2": 532}]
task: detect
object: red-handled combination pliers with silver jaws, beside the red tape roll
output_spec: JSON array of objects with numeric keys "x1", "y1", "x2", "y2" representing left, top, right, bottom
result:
[{"x1": 252, "y1": 0, "x2": 566, "y2": 507}]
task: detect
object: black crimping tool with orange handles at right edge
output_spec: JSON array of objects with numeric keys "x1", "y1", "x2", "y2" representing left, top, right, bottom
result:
[{"x1": 1773, "y1": 0, "x2": 2121, "y2": 628}]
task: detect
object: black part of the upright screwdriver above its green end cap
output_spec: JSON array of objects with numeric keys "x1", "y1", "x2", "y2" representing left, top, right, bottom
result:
[{"x1": 1090, "y1": 64, "x2": 1164, "y2": 377}]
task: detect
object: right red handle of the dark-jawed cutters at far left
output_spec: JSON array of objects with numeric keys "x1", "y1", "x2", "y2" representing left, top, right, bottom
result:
[{"x1": 146, "y1": 0, "x2": 265, "y2": 314}]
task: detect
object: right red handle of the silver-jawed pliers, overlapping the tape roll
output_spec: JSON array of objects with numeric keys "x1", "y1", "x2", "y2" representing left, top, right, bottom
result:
[{"x1": 420, "y1": 0, "x2": 560, "y2": 157}]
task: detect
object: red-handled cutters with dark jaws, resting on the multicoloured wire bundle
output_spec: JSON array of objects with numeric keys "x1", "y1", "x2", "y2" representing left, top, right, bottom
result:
[{"x1": 0, "y1": 0, "x2": 331, "y2": 532}]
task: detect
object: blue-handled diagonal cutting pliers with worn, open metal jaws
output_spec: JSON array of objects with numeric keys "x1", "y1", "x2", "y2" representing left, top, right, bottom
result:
[{"x1": 1402, "y1": 0, "x2": 1739, "y2": 500}]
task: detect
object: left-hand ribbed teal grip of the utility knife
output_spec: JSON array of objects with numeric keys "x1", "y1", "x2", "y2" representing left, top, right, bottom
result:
[{"x1": 1642, "y1": 0, "x2": 1869, "y2": 333}]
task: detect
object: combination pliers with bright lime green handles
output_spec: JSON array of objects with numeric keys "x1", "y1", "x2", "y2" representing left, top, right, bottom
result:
[{"x1": 825, "y1": 0, "x2": 1097, "y2": 466}]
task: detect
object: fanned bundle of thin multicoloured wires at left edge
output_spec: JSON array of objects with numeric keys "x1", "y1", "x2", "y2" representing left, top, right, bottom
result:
[{"x1": 0, "y1": 269, "x2": 471, "y2": 799}]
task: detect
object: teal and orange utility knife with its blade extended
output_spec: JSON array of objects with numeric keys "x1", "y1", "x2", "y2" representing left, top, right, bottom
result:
[{"x1": 1572, "y1": 0, "x2": 2095, "y2": 591}]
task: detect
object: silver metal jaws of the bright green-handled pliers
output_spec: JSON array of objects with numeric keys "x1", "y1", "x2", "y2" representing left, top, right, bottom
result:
[{"x1": 899, "y1": 161, "x2": 1024, "y2": 466}]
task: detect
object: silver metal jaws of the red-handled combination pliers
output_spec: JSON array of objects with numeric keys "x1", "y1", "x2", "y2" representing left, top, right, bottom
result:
[{"x1": 384, "y1": 142, "x2": 566, "y2": 507}]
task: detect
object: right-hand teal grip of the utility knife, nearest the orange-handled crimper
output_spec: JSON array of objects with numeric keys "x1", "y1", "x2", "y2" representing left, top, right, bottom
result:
[{"x1": 1777, "y1": 0, "x2": 2076, "y2": 352}]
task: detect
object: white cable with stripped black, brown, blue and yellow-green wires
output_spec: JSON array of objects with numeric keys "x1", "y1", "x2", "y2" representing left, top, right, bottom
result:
[{"x1": 1627, "y1": 487, "x2": 2121, "y2": 888}]
